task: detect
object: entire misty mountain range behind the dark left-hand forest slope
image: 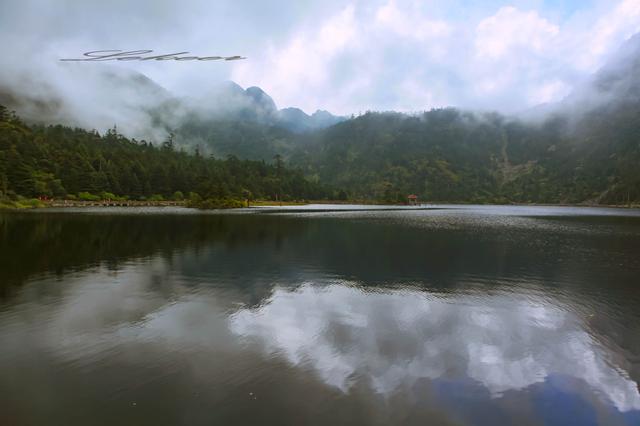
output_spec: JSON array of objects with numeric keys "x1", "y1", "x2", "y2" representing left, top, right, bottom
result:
[{"x1": 3, "y1": 36, "x2": 640, "y2": 204}]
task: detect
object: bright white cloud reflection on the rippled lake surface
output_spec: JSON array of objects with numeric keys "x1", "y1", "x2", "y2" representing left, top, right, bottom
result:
[{"x1": 229, "y1": 284, "x2": 640, "y2": 412}]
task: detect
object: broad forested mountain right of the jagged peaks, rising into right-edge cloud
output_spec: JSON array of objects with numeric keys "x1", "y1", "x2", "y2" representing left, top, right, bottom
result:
[{"x1": 291, "y1": 35, "x2": 640, "y2": 204}]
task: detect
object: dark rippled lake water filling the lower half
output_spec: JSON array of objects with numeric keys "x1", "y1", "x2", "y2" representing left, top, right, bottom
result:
[{"x1": 0, "y1": 206, "x2": 640, "y2": 425}]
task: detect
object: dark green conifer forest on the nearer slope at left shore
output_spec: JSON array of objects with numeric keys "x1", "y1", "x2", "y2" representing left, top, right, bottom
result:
[{"x1": 0, "y1": 106, "x2": 330, "y2": 206}]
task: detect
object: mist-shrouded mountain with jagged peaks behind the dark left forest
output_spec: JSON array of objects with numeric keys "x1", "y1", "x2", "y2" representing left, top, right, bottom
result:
[{"x1": 0, "y1": 70, "x2": 346, "y2": 161}]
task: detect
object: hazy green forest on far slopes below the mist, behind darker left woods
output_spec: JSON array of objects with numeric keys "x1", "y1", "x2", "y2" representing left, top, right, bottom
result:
[{"x1": 168, "y1": 105, "x2": 640, "y2": 204}]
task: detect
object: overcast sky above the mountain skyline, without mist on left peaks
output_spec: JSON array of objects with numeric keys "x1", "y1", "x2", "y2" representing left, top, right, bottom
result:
[{"x1": 0, "y1": 0, "x2": 640, "y2": 114}]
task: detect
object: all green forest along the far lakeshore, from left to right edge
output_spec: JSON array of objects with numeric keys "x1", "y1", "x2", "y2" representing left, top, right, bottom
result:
[{"x1": 0, "y1": 99, "x2": 640, "y2": 206}]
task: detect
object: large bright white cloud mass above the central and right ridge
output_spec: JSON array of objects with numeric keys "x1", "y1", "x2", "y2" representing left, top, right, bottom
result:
[{"x1": 232, "y1": 0, "x2": 640, "y2": 114}]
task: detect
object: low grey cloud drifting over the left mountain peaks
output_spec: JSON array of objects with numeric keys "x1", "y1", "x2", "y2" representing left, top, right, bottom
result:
[{"x1": 0, "y1": 66, "x2": 345, "y2": 141}]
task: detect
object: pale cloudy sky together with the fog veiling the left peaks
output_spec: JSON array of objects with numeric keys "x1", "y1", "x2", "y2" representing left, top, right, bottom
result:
[{"x1": 0, "y1": 0, "x2": 640, "y2": 140}]
